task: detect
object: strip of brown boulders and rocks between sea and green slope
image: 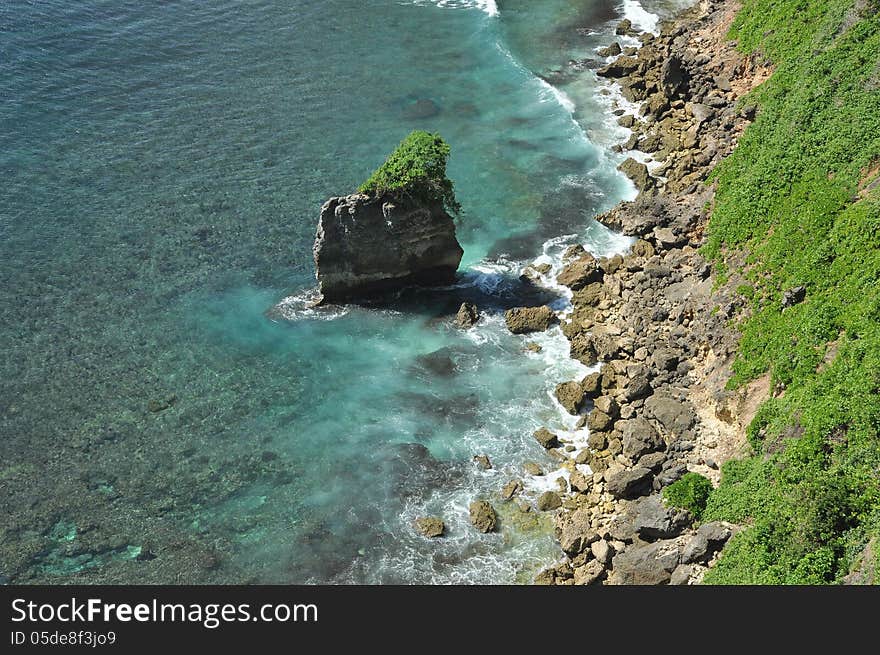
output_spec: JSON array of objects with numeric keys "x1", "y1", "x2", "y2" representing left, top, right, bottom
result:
[{"x1": 503, "y1": 0, "x2": 769, "y2": 585}]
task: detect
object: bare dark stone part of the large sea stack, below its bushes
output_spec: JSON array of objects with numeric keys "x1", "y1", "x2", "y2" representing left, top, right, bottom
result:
[{"x1": 314, "y1": 194, "x2": 463, "y2": 303}]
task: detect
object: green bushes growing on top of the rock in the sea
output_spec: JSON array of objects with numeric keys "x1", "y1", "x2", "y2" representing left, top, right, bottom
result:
[{"x1": 358, "y1": 130, "x2": 461, "y2": 214}]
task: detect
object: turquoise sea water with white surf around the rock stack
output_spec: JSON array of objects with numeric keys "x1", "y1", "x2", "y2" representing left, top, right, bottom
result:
[{"x1": 0, "y1": 0, "x2": 688, "y2": 583}]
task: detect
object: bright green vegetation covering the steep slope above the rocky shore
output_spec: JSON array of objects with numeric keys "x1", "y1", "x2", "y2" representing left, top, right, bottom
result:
[{"x1": 703, "y1": 0, "x2": 880, "y2": 584}]
